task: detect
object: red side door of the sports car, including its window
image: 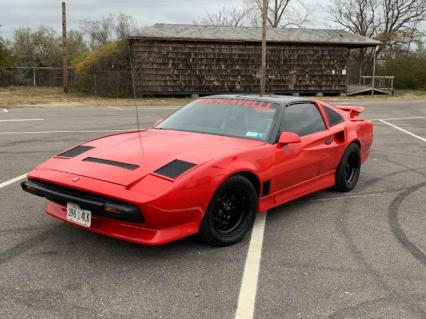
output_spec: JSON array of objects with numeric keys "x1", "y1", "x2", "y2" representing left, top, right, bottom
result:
[{"x1": 273, "y1": 102, "x2": 330, "y2": 192}]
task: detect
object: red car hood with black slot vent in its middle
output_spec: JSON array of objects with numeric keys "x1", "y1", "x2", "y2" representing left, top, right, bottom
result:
[{"x1": 39, "y1": 129, "x2": 265, "y2": 186}]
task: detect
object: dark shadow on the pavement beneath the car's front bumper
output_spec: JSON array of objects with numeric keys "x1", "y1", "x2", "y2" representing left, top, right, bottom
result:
[{"x1": 22, "y1": 221, "x2": 249, "y2": 262}]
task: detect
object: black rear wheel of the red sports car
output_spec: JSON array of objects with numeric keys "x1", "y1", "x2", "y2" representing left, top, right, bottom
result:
[{"x1": 334, "y1": 143, "x2": 361, "y2": 192}]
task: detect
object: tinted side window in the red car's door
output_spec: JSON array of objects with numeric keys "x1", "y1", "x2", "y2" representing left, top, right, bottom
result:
[{"x1": 281, "y1": 103, "x2": 326, "y2": 136}]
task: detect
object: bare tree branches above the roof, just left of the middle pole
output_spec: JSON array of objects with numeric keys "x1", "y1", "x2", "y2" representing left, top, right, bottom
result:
[{"x1": 193, "y1": 7, "x2": 248, "y2": 27}]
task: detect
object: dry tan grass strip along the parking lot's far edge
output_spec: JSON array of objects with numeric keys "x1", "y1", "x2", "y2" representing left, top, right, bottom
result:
[{"x1": 0, "y1": 87, "x2": 426, "y2": 108}]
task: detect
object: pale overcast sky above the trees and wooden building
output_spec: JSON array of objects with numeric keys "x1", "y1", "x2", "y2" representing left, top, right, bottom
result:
[{"x1": 0, "y1": 0, "x2": 332, "y2": 39}]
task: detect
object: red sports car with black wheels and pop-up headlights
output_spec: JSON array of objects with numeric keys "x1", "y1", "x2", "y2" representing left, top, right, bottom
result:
[{"x1": 22, "y1": 95, "x2": 373, "y2": 246}]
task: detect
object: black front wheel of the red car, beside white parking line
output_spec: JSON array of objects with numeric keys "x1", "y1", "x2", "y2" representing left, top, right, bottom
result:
[{"x1": 199, "y1": 175, "x2": 258, "y2": 246}]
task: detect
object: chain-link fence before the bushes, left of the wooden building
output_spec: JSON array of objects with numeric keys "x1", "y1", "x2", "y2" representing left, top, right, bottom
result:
[{"x1": 0, "y1": 67, "x2": 133, "y2": 97}]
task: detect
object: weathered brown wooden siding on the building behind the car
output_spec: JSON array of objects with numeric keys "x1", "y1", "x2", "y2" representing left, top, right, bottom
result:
[{"x1": 131, "y1": 39, "x2": 348, "y2": 96}]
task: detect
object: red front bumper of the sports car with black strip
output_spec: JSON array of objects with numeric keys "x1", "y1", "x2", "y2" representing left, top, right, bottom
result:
[{"x1": 22, "y1": 170, "x2": 202, "y2": 245}]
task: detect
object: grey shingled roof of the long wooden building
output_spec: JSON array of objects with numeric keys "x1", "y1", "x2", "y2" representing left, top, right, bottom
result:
[{"x1": 130, "y1": 24, "x2": 380, "y2": 47}]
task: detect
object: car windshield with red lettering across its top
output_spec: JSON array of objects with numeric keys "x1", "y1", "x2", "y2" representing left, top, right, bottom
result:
[{"x1": 155, "y1": 98, "x2": 277, "y2": 141}]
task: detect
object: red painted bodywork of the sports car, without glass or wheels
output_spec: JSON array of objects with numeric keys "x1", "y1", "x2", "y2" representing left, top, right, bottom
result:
[{"x1": 24, "y1": 98, "x2": 373, "y2": 245}]
